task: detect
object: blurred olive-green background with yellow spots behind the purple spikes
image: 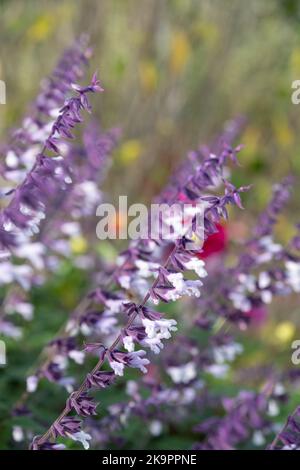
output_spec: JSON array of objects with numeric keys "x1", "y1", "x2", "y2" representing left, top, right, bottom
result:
[{"x1": 0, "y1": 0, "x2": 300, "y2": 448}]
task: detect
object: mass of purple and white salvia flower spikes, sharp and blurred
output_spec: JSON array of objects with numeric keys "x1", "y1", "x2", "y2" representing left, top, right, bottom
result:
[{"x1": 0, "y1": 37, "x2": 300, "y2": 450}]
